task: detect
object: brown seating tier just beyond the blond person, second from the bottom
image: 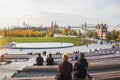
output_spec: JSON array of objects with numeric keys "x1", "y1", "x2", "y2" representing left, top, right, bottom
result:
[{"x1": 23, "y1": 59, "x2": 120, "y2": 71}]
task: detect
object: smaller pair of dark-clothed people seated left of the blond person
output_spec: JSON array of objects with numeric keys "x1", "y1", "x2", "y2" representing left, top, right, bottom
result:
[{"x1": 36, "y1": 53, "x2": 54, "y2": 65}]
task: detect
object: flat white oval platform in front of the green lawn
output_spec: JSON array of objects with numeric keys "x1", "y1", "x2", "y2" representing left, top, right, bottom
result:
[{"x1": 12, "y1": 42, "x2": 74, "y2": 49}]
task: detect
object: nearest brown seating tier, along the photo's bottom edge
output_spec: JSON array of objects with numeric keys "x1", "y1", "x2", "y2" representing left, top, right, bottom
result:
[{"x1": 5, "y1": 71, "x2": 120, "y2": 80}]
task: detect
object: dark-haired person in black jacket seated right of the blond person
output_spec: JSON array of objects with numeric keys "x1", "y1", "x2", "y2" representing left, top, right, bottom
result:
[{"x1": 73, "y1": 53, "x2": 88, "y2": 80}]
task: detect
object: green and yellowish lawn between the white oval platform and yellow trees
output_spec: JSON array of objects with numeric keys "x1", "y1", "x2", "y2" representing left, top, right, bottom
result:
[{"x1": 0, "y1": 37, "x2": 94, "y2": 46}]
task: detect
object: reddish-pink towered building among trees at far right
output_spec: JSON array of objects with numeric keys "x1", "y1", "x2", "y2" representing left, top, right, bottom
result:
[{"x1": 96, "y1": 23, "x2": 108, "y2": 39}]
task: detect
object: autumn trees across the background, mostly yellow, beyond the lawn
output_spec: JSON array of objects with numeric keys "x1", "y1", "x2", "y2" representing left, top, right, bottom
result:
[{"x1": 0, "y1": 28, "x2": 120, "y2": 40}]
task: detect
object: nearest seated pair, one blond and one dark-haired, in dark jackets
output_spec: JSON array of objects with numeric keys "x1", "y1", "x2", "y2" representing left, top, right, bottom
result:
[{"x1": 56, "y1": 53, "x2": 88, "y2": 80}]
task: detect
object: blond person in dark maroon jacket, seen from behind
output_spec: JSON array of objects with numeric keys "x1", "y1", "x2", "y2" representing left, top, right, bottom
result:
[{"x1": 58, "y1": 54, "x2": 73, "y2": 80}]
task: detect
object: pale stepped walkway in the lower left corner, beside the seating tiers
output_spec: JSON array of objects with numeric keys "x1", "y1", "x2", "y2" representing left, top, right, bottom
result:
[{"x1": 0, "y1": 58, "x2": 35, "y2": 80}]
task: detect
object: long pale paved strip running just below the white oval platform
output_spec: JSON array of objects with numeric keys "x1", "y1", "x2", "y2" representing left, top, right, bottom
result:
[{"x1": 0, "y1": 43, "x2": 112, "y2": 54}]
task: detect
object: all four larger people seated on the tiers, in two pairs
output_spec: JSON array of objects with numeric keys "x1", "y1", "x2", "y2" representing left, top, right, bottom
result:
[{"x1": 36, "y1": 53, "x2": 88, "y2": 80}]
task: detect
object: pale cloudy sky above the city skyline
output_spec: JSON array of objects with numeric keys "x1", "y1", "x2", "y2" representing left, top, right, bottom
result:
[{"x1": 0, "y1": 0, "x2": 120, "y2": 28}]
